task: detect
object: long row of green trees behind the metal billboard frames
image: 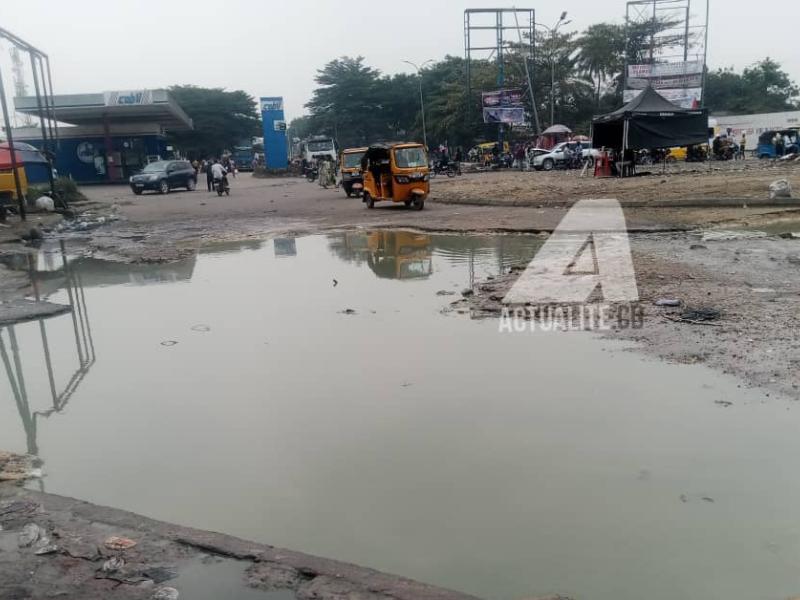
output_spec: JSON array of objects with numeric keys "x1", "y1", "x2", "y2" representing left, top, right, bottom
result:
[{"x1": 289, "y1": 20, "x2": 800, "y2": 147}]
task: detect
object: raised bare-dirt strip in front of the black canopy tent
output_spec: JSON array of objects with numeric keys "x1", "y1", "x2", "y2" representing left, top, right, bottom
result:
[{"x1": 434, "y1": 160, "x2": 800, "y2": 206}]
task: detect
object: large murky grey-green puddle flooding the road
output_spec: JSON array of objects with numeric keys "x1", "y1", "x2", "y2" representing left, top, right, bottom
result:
[{"x1": 0, "y1": 232, "x2": 800, "y2": 600}]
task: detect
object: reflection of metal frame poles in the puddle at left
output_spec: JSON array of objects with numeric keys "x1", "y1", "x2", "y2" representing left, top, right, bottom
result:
[{"x1": 0, "y1": 242, "x2": 96, "y2": 466}]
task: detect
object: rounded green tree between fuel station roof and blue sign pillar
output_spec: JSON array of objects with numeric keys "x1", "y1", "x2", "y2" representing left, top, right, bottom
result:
[{"x1": 168, "y1": 85, "x2": 261, "y2": 158}]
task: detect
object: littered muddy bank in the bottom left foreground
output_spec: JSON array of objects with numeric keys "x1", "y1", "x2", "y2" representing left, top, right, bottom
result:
[{"x1": 0, "y1": 485, "x2": 482, "y2": 600}]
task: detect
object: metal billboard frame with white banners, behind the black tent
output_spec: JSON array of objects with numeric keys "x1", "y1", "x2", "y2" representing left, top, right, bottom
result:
[{"x1": 623, "y1": 0, "x2": 709, "y2": 106}]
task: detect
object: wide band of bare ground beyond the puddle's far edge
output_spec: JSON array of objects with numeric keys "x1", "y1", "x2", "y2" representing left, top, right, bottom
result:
[{"x1": 14, "y1": 161, "x2": 800, "y2": 261}]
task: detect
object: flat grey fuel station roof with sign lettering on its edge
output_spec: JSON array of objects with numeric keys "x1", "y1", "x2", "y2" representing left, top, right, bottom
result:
[{"x1": 14, "y1": 90, "x2": 193, "y2": 131}]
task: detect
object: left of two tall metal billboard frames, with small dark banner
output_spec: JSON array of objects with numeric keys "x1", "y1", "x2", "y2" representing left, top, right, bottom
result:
[{"x1": 464, "y1": 8, "x2": 540, "y2": 136}]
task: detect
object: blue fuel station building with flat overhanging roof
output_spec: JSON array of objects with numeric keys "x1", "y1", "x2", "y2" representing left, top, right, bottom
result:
[{"x1": 14, "y1": 90, "x2": 193, "y2": 183}]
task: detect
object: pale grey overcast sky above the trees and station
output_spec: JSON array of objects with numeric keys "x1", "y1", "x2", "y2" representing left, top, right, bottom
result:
[{"x1": 0, "y1": 0, "x2": 800, "y2": 119}]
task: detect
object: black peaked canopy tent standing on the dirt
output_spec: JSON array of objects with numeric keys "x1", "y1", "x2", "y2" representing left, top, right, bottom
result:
[{"x1": 592, "y1": 87, "x2": 708, "y2": 152}]
